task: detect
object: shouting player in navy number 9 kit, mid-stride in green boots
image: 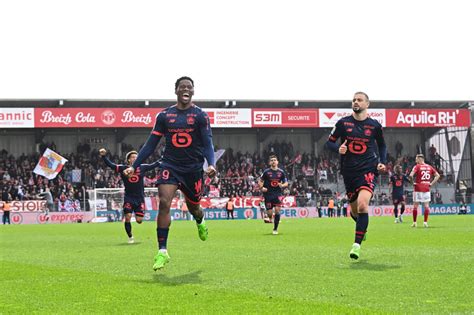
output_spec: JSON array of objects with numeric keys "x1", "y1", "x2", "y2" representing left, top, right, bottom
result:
[{"x1": 125, "y1": 77, "x2": 216, "y2": 270}]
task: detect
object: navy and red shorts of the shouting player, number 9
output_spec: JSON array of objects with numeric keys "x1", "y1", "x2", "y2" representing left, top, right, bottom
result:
[{"x1": 156, "y1": 166, "x2": 204, "y2": 204}]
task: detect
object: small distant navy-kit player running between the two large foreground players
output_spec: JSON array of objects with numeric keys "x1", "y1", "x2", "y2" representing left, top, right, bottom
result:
[{"x1": 258, "y1": 155, "x2": 288, "y2": 235}]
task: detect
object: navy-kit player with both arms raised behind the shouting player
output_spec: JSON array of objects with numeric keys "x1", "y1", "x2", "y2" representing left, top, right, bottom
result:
[{"x1": 99, "y1": 149, "x2": 160, "y2": 244}]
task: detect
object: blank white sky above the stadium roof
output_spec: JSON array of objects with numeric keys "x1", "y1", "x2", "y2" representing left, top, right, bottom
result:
[{"x1": 0, "y1": 0, "x2": 474, "y2": 101}]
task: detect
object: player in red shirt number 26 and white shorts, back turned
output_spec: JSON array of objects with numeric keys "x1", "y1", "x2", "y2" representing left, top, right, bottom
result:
[{"x1": 409, "y1": 154, "x2": 439, "y2": 227}]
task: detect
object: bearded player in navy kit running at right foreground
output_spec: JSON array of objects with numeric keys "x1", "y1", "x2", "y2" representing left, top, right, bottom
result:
[{"x1": 326, "y1": 92, "x2": 387, "y2": 259}]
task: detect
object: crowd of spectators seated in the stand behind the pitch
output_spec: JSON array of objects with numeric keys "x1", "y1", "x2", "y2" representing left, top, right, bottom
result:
[{"x1": 0, "y1": 141, "x2": 466, "y2": 210}]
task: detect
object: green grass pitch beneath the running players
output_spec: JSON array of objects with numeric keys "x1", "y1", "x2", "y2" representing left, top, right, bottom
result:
[{"x1": 0, "y1": 216, "x2": 474, "y2": 314}]
